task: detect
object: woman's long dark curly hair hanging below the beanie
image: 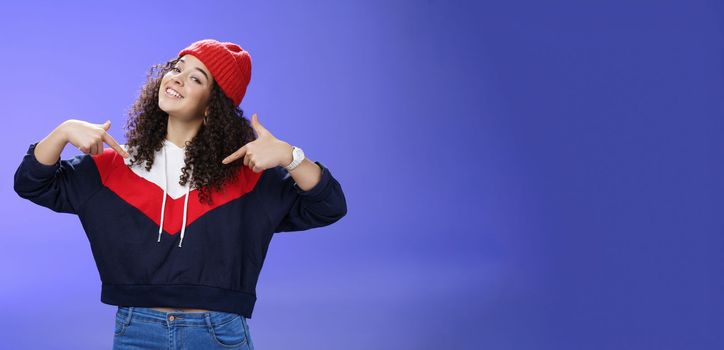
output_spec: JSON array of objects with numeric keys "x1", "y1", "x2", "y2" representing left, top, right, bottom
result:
[{"x1": 119, "y1": 57, "x2": 256, "y2": 204}]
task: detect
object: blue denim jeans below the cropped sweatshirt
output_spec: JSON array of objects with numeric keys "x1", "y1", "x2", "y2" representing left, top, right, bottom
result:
[{"x1": 113, "y1": 306, "x2": 254, "y2": 350}]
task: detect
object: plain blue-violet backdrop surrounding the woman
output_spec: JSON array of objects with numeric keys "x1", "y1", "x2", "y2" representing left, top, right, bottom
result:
[{"x1": 0, "y1": 0, "x2": 724, "y2": 349}]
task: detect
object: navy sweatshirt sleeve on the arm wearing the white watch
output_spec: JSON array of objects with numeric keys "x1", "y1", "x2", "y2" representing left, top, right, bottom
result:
[{"x1": 260, "y1": 161, "x2": 347, "y2": 232}]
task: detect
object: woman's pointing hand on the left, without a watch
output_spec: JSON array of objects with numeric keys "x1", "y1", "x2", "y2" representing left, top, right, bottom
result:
[{"x1": 63, "y1": 119, "x2": 129, "y2": 158}]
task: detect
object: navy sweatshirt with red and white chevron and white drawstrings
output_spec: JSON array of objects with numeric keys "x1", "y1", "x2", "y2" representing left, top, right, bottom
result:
[{"x1": 14, "y1": 140, "x2": 347, "y2": 318}]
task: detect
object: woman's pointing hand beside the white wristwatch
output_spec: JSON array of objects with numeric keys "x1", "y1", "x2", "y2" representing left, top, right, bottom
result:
[{"x1": 221, "y1": 113, "x2": 293, "y2": 173}]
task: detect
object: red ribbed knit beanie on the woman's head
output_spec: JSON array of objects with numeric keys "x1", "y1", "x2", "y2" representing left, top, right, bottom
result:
[{"x1": 178, "y1": 39, "x2": 251, "y2": 106}]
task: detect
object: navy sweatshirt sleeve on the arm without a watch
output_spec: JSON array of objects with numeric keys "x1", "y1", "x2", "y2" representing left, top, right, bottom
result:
[{"x1": 13, "y1": 142, "x2": 99, "y2": 214}]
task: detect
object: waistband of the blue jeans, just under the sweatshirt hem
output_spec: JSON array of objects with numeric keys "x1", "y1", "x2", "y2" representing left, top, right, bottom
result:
[{"x1": 116, "y1": 306, "x2": 242, "y2": 326}]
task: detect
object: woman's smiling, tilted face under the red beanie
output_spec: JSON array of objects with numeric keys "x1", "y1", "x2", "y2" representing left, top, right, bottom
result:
[{"x1": 158, "y1": 55, "x2": 214, "y2": 120}]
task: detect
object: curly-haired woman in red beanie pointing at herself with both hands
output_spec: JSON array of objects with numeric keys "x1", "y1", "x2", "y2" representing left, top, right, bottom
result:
[{"x1": 14, "y1": 39, "x2": 347, "y2": 349}]
